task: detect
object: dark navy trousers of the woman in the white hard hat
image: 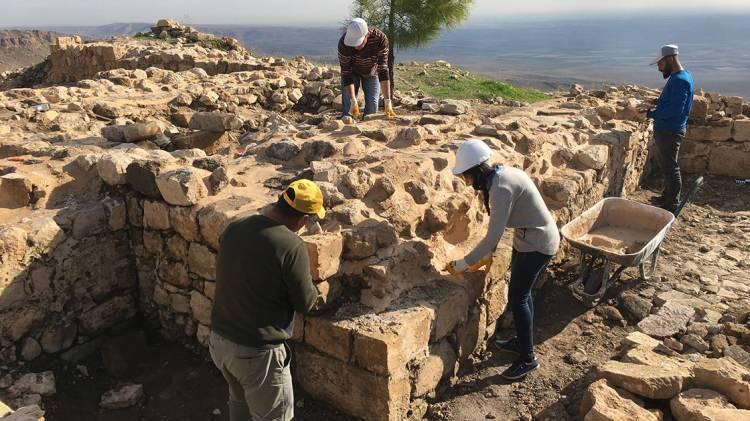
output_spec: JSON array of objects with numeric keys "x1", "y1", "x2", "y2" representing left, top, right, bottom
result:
[{"x1": 508, "y1": 249, "x2": 552, "y2": 361}]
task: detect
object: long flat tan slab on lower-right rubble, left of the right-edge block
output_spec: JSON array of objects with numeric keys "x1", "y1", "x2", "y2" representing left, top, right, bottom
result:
[{"x1": 598, "y1": 361, "x2": 691, "y2": 399}]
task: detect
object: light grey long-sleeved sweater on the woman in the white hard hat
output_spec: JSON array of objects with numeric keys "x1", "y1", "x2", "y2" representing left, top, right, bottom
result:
[{"x1": 464, "y1": 167, "x2": 560, "y2": 266}]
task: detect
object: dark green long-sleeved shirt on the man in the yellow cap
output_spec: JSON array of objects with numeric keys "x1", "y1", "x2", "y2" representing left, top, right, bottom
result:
[{"x1": 211, "y1": 215, "x2": 317, "y2": 348}]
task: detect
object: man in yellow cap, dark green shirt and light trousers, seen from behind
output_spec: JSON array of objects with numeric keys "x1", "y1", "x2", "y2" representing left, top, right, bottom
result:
[{"x1": 209, "y1": 180, "x2": 325, "y2": 421}]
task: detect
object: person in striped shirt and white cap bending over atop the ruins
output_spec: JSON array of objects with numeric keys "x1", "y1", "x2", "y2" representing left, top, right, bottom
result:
[{"x1": 338, "y1": 18, "x2": 396, "y2": 118}]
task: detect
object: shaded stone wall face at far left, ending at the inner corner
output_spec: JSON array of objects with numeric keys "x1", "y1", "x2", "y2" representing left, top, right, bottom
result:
[{"x1": 0, "y1": 195, "x2": 138, "y2": 364}]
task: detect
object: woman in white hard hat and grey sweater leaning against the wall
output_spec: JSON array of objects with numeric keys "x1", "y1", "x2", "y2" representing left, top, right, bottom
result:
[{"x1": 446, "y1": 139, "x2": 560, "y2": 380}]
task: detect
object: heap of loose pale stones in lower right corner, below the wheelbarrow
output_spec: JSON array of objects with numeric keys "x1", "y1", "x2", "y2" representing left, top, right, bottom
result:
[{"x1": 581, "y1": 251, "x2": 750, "y2": 421}]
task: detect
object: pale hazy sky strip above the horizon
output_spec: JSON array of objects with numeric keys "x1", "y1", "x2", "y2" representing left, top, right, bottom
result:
[{"x1": 0, "y1": 0, "x2": 750, "y2": 27}]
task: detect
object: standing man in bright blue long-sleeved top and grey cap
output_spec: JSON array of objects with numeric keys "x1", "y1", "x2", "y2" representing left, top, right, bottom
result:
[{"x1": 640, "y1": 45, "x2": 693, "y2": 212}]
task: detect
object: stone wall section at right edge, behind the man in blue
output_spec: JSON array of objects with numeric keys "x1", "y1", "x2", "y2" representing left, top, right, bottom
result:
[{"x1": 680, "y1": 94, "x2": 750, "y2": 178}]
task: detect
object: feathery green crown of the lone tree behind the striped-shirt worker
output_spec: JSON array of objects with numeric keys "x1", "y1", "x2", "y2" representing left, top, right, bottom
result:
[{"x1": 354, "y1": 0, "x2": 473, "y2": 48}]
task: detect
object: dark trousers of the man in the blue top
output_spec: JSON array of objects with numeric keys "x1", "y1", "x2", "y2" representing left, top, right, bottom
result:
[{"x1": 654, "y1": 130, "x2": 685, "y2": 211}]
